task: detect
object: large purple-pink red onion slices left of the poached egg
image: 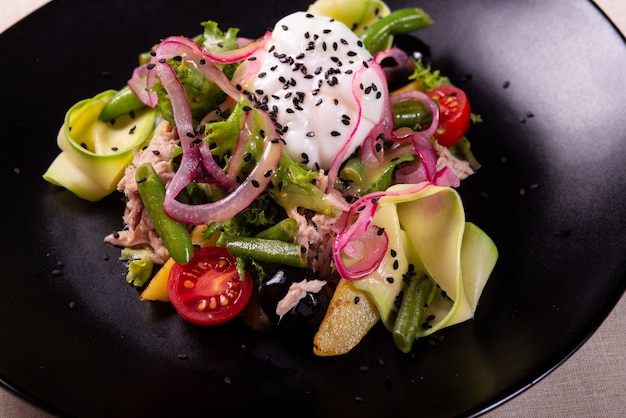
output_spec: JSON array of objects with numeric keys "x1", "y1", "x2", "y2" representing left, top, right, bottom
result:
[{"x1": 129, "y1": 34, "x2": 283, "y2": 224}]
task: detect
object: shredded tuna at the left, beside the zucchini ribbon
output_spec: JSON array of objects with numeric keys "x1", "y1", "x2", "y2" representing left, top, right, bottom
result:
[{"x1": 104, "y1": 122, "x2": 177, "y2": 264}]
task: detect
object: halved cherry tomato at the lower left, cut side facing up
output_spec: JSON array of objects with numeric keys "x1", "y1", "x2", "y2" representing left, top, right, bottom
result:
[{"x1": 167, "y1": 247, "x2": 253, "y2": 325}]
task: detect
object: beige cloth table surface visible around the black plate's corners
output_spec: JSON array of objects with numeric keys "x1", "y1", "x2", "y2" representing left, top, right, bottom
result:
[{"x1": 0, "y1": 0, "x2": 626, "y2": 418}]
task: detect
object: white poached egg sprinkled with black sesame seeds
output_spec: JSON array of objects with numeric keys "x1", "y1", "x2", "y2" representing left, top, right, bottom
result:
[{"x1": 235, "y1": 12, "x2": 385, "y2": 169}]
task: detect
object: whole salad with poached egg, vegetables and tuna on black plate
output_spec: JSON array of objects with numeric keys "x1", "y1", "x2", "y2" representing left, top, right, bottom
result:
[{"x1": 44, "y1": 0, "x2": 498, "y2": 356}]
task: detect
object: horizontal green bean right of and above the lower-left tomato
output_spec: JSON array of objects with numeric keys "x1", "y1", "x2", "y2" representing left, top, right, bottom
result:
[{"x1": 226, "y1": 237, "x2": 307, "y2": 267}]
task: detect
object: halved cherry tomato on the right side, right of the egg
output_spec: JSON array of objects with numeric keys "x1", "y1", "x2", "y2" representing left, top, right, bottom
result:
[{"x1": 426, "y1": 84, "x2": 471, "y2": 147}]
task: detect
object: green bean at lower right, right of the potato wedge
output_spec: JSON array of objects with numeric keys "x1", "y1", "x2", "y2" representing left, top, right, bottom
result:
[{"x1": 393, "y1": 273, "x2": 433, "y2": 353}]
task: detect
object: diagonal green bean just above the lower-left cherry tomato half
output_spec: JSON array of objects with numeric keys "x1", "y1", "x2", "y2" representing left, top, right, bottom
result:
[{"x1": 135, "y1": 163, "x2": 193, "y2": 264}]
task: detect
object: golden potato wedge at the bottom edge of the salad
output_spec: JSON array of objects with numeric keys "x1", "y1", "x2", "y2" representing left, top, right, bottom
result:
[{"x1": 313, "y1": 279, "x2": 380, "y2": 356}]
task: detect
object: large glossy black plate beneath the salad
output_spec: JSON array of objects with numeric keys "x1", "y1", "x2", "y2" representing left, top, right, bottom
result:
[{"x1": 0, "y1": 0, "x2": 626, "y2": 417}]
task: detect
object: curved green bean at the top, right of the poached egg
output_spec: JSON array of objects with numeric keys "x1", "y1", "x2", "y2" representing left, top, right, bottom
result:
[{"x1": 361, "y1": 8, "x2": 434, "y2": 54}]
